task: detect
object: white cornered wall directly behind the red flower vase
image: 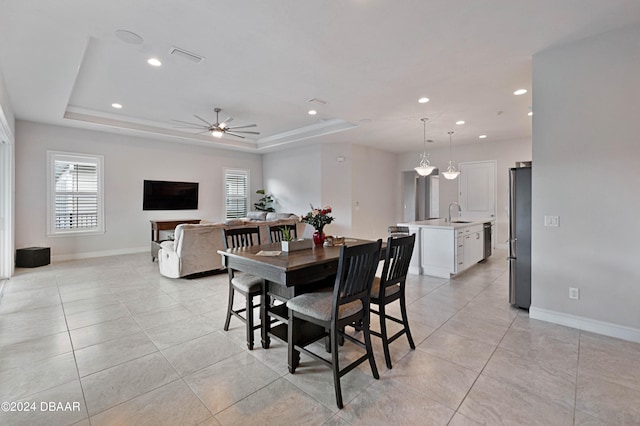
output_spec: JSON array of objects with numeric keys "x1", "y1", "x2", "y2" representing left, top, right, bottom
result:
[{"x1": 263, "y1": 143, "x2": 398, "y2": 239}]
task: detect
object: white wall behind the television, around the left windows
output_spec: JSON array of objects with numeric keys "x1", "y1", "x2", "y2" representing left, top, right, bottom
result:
[{"x1": 15, "y1": 121, "x2": 262, "y2": 260}]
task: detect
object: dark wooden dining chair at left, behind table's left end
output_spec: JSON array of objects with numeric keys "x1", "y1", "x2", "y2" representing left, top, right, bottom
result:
[{"x1": 222, "y1": 227, "x2": 264, "y2": 350}]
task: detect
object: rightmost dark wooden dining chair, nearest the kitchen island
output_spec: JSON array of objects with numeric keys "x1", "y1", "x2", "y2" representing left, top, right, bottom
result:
[{"x1": 371, "y1": 234, "x2": 416, "y2": 368}]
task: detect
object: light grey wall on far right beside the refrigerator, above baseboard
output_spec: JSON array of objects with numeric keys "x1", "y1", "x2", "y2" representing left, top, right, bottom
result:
[{"x1": 531, "y1": 26, "x2": 640, "y2": 341}]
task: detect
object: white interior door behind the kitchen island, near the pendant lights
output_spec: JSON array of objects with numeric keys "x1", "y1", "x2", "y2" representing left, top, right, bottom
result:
[{"x1": 458, "y1": 161, "x2": 497, "y2": 219}]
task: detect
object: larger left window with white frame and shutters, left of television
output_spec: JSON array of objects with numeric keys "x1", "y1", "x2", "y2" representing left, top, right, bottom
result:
[{"x1": 47, "y1": 151, "x2": 104, "y2": 235}]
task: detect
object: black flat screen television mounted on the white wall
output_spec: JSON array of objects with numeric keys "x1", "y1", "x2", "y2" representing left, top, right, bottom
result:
[{"x1": 142, "y1": 180, "x2": 198, "y2": 210}]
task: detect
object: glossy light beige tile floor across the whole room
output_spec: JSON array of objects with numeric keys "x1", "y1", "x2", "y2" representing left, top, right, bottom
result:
[{"x1": 0, "y1": 251, "x2": 640, "y2": 426}]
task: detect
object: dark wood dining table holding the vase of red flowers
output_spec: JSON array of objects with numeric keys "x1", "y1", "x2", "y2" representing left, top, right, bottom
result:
[{"x1": 218, "y1": 238, "x2": 371, "y2": 364}]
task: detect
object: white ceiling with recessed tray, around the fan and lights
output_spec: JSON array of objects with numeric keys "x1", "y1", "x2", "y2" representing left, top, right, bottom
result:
[{"x1": 0, "y1": 0, "x2": 640, "y2": 152}]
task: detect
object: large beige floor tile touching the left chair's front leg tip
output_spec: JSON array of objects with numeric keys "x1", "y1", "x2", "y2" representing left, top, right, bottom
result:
[{"x1": 184, "y1": 352, "x2": 278, "y2": 414}]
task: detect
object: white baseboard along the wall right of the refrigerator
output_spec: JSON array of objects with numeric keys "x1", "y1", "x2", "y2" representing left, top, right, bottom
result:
[{"x1": 529, "y1": 306, "x2": 640, "y2": 343}]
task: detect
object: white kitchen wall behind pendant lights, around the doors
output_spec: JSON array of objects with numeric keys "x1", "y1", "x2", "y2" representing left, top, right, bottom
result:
[{"x1": 396, "y1": 138, "x2": 535, "y2": 247}]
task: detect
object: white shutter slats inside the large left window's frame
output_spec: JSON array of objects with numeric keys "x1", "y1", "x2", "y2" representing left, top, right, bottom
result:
[{"x1": 54, "y1": 160, "x2": 99, "y2": 230}]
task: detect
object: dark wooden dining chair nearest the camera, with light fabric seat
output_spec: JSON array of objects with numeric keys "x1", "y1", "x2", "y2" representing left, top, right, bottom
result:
[{"x1": 287, "y1": 240, "x2": 382, "y2": 408}]
